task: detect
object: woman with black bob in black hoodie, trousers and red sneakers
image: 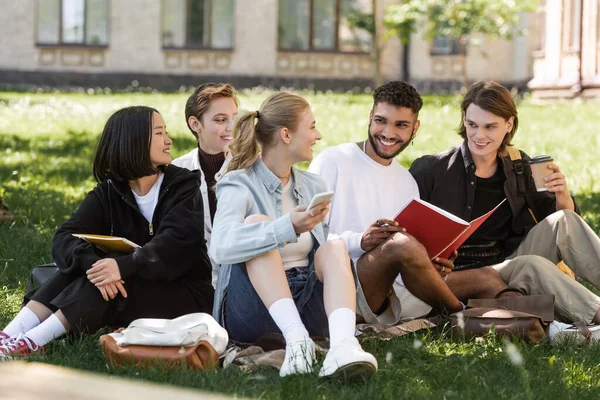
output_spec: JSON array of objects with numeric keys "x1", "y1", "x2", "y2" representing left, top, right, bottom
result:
[{"x1": 0, "y1": 106, "x2": 214, "y2": 357}]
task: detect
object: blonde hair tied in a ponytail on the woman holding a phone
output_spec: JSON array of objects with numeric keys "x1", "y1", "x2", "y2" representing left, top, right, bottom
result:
[{"x1": 227, "y1": 92, "x2": 310, "y2": 172}]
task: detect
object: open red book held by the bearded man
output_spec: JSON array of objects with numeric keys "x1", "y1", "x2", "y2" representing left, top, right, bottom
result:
[{"x1": 394, "y1": 197, "x2": 506, "y2": 259}]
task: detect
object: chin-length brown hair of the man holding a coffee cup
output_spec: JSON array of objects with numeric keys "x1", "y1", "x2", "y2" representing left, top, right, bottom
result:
[{"x1": 458, "y1": 81, "x2": 519, "y2": 154}]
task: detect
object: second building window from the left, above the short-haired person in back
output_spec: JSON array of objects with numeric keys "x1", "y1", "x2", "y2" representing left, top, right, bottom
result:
[{"x1": 162, "y1": 0, "x2": 234, "y2": 49}]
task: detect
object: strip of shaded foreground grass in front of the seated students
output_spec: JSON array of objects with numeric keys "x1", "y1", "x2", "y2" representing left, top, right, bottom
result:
[{"x1": 9, "y1": 328, "x2": 600, "y2": 400}]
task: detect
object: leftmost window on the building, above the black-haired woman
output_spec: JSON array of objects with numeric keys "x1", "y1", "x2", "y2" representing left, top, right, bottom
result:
[{"x1": 37, "y1": 0, "x2": 108, "y2": 46}]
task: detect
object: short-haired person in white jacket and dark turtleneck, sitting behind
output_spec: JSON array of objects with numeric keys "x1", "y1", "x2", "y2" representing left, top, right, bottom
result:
[{"x1": 173, "y1": 83, "x2": 238, "y2": 286}]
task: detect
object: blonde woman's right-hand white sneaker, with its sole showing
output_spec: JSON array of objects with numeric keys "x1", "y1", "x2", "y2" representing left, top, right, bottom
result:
[{"x1": 319, "y1": 337, "x2": 377, "y2": 381}]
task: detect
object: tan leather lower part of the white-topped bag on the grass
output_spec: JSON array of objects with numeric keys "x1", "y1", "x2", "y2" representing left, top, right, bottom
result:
[{"x1": 100, "y1": 335, "x2": 219, "y2": 370}]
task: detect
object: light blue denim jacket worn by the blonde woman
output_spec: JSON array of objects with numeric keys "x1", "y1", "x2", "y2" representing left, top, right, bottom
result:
[{"x1": 209, "y1": 159, "x2": 329, "y2": 323}]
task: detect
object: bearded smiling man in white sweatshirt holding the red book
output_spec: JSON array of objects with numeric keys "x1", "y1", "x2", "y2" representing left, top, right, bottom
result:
[{"x1": 309, "y1": 81, "x2": 492, "y2": 324}]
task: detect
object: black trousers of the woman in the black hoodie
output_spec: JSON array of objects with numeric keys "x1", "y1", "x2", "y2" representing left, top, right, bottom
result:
[{"x1": 25, "y1": 271, "x2": 214, "y2": 333}]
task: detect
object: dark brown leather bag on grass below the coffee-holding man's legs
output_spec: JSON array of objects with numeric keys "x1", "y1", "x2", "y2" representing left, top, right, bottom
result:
[{"x1": 450, "y1": 295, "x2": 554, "y2": 343}]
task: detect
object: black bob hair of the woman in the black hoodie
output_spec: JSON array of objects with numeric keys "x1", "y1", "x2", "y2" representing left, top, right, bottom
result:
[{"x1": 93, "y1": 106, "x2": 160, "y2": 182}]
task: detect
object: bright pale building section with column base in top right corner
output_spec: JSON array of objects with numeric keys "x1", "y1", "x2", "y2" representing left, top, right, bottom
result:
[{"x1": 529, "y1": 0, "x2": 600, "y2": 98}]
